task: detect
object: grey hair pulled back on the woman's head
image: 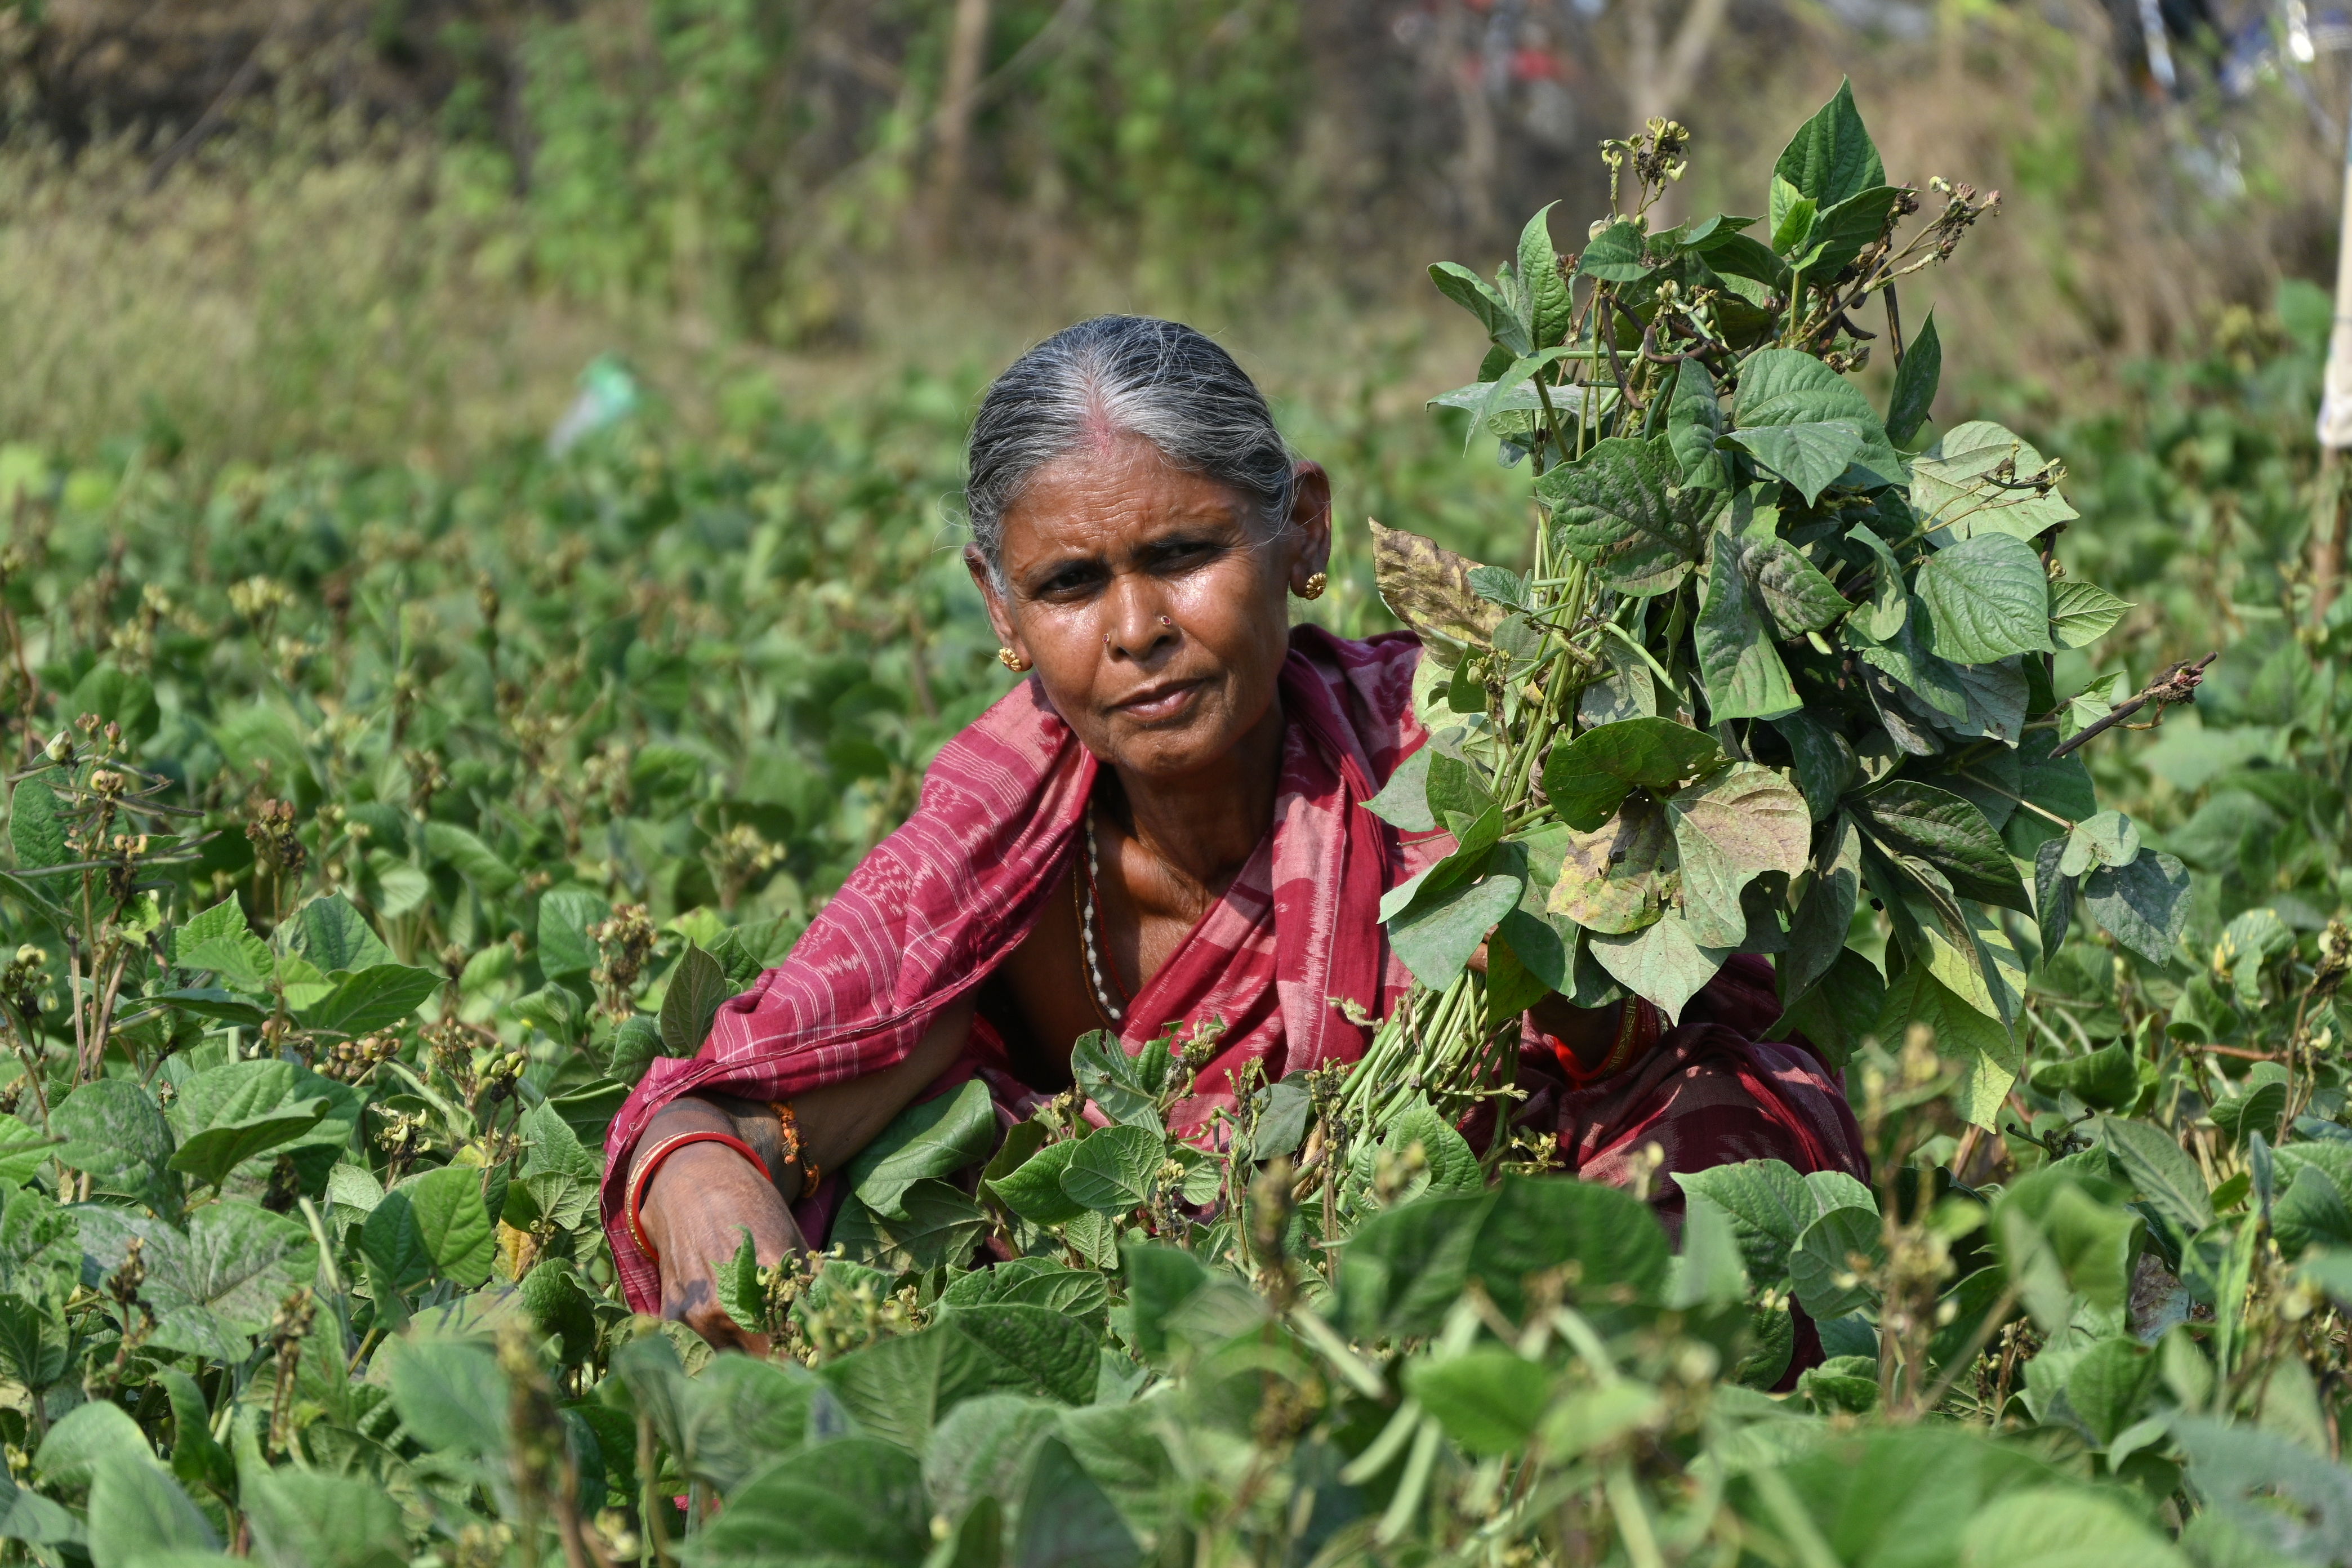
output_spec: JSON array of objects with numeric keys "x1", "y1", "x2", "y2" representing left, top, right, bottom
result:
[{"x1": 964, "y1": 315, "x2": 1296, "y2": 587}]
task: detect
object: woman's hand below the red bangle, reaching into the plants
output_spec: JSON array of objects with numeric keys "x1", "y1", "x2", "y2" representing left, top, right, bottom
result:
[{"x1": 638, "y1": 1140, "x2": 807, "y2": 1356}]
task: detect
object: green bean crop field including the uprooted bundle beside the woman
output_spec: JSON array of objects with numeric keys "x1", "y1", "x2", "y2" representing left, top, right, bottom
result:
[{"x1": 0, "y1": 94, "x2": 2352, "y2": 1568}]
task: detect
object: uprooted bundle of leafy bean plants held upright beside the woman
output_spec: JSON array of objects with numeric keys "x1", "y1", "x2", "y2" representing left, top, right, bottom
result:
[{"x1": 1348, "y1": 90, "x2": 2194, "y2": 1128}]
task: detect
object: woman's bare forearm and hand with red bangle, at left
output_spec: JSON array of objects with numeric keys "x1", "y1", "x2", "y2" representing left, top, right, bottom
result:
[{"x1": 638, "y1": 1001, "x2": 972, "y2": 1354}]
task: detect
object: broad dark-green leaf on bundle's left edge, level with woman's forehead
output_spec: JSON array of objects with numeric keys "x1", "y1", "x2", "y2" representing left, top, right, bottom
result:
[{"x1": 1536, "y1": 435, "x2": 1724, "y2": 597}]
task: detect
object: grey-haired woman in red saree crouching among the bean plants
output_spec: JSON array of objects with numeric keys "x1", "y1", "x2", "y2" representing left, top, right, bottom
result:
[{"x1": 604, "y1": 317, "x2": 1863, "y2": 1342}]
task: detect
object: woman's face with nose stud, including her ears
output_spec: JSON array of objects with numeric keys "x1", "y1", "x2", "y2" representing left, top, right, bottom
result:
[{"x1": 966, "y1": 435, "x2": 1331, "y2": 781}]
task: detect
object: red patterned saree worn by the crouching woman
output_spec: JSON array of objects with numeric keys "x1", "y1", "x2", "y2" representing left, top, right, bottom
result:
[{"x1": 602, "y1": 627, "x2": 1860, "y2": 1312}]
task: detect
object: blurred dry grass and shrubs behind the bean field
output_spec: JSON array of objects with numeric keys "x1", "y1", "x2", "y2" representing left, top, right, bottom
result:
[{"x1": 0, "y1": 0, "x2": 2352, "y2": 473}]
